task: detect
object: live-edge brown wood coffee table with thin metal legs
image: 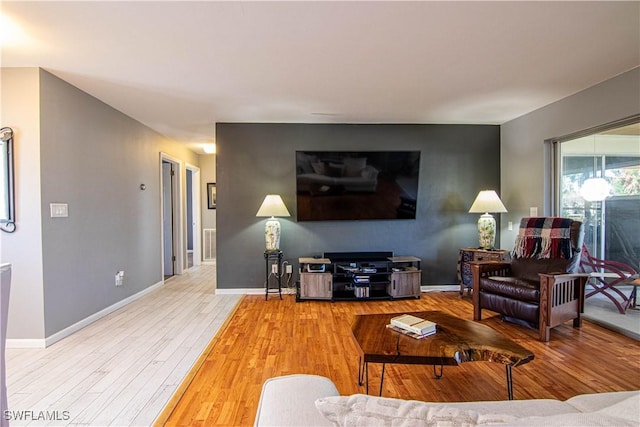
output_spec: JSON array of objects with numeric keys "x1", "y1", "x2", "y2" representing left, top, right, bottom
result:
[{"x1": 351, "y1": 311, "x2": 534, "y2": 400}]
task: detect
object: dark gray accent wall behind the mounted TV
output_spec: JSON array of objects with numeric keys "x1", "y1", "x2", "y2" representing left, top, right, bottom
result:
[{"x1": 216, "y1": 123, "x2": 500, "y2": 288}]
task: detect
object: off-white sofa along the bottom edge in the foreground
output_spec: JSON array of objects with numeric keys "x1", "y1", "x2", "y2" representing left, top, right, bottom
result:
[{"x1": 255, "y1": 375, "x2": 640, "y2": 427}]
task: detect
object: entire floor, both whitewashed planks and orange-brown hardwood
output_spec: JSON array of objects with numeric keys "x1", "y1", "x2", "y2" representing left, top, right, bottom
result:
[{"x1": 6, "y1": 266, "x2": 640, "y2": 426}]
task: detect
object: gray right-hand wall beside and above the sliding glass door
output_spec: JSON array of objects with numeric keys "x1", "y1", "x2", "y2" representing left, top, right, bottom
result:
[{"x1": 500, "y1": 68, "x2": 640, "y2": 249}]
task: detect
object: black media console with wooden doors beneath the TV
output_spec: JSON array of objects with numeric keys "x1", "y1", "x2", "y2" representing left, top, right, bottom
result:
[{"x1": 296, "y1": 252, "x2": 421, "y2": 301}]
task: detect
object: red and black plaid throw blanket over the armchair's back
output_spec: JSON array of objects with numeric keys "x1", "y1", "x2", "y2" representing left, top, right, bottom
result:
[{"x1": 513, "y1": 217, "x2": 573, "y2": 259}]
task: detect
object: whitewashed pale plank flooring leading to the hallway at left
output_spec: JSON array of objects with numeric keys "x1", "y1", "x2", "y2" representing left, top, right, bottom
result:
[{"x1": 6, "y1": 266, "x2": 241, "y2": 426}]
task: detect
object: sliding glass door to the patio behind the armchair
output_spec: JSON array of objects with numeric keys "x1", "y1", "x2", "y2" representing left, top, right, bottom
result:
[{"x1": 553, "y1": 117, "x2": 640, "y2": 339}]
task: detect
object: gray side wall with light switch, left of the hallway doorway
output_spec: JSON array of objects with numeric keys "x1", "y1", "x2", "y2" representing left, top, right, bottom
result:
[{"x1": 40, "y1": 71, "x2": 198, "y2": 336}]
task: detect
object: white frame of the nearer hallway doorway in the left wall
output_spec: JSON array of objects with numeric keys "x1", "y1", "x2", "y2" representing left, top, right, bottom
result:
[{"x1": 158, "y1": 152, "x2": 186, "y2": 280}]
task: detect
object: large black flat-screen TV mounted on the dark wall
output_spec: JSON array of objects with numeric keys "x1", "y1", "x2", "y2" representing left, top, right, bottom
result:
[{"x1": 296, "y1": 151, "x2": 420, "y2": 221}]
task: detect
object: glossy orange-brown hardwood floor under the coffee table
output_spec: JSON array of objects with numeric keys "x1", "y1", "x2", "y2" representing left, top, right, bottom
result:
[{"x1": 162, "y1": 292, "x2": 640, "y2": 426}]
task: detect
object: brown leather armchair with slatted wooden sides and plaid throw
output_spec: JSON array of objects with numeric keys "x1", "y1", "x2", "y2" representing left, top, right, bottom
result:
[{"x1": 471, "y1": 217, "x2": 587, "y2": 341}]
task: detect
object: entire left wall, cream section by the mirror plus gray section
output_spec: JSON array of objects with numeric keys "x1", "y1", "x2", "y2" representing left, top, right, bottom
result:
[{"x1": 2, "y1": 68, "x2": 198, "y2": 339}]
